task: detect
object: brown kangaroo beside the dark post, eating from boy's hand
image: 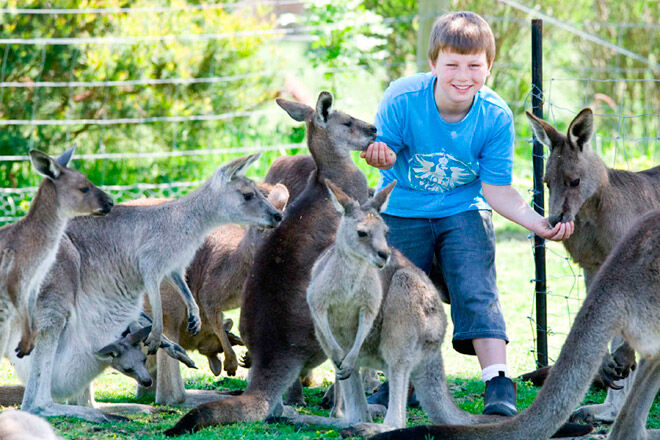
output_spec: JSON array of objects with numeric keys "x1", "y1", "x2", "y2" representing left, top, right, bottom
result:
[{"x1": 527, "y1": 108, "x2": 660, "y2": 423}]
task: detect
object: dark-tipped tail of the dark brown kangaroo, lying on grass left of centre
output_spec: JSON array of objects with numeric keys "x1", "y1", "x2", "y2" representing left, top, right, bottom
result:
[{"x1": 165, "y1": 394, "x2": 269, "y2": 437}]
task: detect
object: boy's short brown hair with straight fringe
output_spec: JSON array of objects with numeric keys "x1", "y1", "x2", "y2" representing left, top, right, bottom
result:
[{"x1": 428, "y1": 11, "x2": 495, "y2": 66}]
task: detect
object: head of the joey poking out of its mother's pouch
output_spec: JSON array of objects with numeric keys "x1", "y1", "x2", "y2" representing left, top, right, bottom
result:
[{"x1": 96, "y1": 326, "x2": 153, "y2": 387}]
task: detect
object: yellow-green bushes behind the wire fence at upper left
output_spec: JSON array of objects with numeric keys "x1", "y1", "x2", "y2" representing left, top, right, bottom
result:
[{"x1": 0, "y1": 0, "x2": 278, "y2": 186}]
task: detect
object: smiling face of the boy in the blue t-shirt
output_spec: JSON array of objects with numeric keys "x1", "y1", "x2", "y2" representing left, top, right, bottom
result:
[{"x1": 429, "y1": 50, "x2": 490, "y2": 108}]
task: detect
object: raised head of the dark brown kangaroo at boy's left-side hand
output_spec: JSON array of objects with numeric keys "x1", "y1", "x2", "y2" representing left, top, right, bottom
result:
[{"x1": 277, "y1": 92, "x2": 376, "y2": 156}]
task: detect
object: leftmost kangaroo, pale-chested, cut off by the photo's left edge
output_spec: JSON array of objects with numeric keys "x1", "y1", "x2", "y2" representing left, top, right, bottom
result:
[{"x1": 0, "y1": 147, "x2": 112, "y2": 357}]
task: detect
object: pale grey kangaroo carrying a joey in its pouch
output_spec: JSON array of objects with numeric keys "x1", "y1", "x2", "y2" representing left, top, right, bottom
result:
[{"x1": 16, "y1": 155, "x2": 282, "y2": 422}]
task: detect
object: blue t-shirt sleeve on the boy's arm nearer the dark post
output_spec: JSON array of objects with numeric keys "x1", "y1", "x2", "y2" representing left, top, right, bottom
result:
[{"x1": 479, "y1": 112, "x2": 516, "y2": 185}]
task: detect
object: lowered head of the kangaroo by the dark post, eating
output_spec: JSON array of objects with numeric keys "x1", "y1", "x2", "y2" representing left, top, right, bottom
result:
[{"x1": 527, "y1": 108, "x2": 599, "y2": 226}]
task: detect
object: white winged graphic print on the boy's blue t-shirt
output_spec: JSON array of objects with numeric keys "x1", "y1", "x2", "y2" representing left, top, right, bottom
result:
[{"x1": 408, "y1": 153, "x2": 479, "y2": 192}]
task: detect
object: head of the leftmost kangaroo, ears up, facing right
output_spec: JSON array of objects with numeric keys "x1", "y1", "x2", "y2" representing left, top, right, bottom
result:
[{"x1": 30, "y1": 147, "x2": 113, "y2": 217}]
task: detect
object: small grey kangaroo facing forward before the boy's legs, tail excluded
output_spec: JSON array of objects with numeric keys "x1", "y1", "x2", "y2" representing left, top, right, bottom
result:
[{"x1": 307, "y1": 181, "x2": 420, "y2": 429}]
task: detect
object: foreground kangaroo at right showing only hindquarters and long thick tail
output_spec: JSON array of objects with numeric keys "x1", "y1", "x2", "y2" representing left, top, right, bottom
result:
[{"x1": 374, "y1": 210, "x2": 660, "y2": 440}]
